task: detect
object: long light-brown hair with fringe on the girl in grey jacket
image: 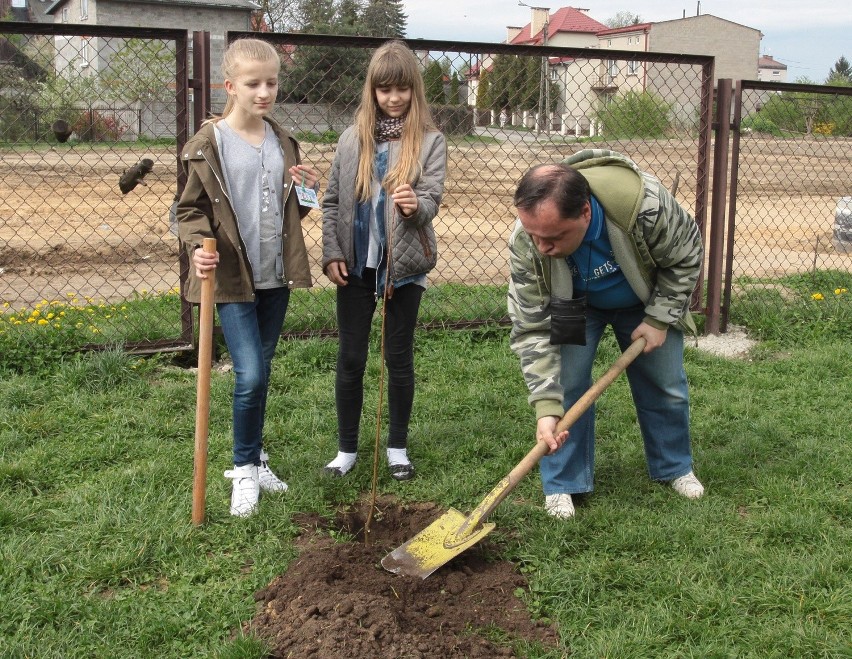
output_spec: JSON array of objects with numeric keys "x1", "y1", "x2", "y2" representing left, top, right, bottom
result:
[{"x1": 355, "y1": 41, "x2": 435, "y2": 201}]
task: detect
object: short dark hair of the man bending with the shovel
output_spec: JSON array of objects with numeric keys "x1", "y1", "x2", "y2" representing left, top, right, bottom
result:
[{"x1": 515, "y1": 163, "x2": 592, "y2": 219}]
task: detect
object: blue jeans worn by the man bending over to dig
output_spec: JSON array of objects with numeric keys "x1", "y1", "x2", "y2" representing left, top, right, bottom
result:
[{"x1": 540, "y1": 306, "x2": 692, "y2": 495}]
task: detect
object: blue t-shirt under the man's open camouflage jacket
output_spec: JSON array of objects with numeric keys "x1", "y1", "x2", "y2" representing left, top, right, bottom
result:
[{"x1": 565, "y1": 196, "x2": 642, "y2": 309}]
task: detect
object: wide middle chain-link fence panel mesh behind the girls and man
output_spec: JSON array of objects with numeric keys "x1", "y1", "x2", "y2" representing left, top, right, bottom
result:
[{"x1": 231, "y1": 33, "x2": 712, "y2": 333}]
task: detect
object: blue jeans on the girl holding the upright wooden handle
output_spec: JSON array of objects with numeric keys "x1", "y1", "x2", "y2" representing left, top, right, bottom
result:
[{"x1": 216, "y1": 286, "x2": 290, "y2": 467}]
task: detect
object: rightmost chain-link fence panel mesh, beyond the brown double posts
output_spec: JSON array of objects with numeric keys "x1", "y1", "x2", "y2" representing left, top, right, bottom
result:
[{"x1": 726, "y1": 81, "x2": 852, "y2": 326}]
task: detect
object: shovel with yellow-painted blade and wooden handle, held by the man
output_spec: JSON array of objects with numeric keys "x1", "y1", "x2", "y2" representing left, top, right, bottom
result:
[{"x1": 382, "y1": 338, "x2": 645, "y2": 579}]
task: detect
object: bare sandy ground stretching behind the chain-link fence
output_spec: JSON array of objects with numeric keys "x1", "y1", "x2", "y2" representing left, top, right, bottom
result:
[{"x1": 0, "y1": 138, "x2": 852, "y2": 308}]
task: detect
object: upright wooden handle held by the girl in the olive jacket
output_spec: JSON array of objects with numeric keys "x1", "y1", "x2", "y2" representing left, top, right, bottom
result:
[{"x1": 192, "y1": 238, "x2": 216, "y2": 526}]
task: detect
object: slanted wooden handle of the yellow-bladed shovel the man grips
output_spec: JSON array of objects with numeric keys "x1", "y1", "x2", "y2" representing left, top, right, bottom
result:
[{"x1": 457, "y1": 338, "x2": 645, "y2": 537}]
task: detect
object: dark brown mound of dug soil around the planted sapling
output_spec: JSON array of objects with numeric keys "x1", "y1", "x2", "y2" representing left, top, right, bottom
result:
[{"x1": 246, "y1": 497, "x2": 558, "y2": 659}]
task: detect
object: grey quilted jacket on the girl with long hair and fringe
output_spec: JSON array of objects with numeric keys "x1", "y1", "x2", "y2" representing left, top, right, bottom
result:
[{"x1": 322, "y1": 126, "x2": 447, "y2": 281}]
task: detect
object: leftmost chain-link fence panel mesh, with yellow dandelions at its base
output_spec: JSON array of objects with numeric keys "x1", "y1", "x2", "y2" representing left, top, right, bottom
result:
[{"x1": 0, "y1": 23, "x2": 186, "y2": 368}]
